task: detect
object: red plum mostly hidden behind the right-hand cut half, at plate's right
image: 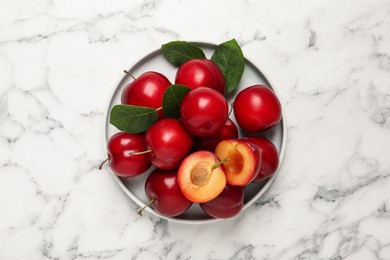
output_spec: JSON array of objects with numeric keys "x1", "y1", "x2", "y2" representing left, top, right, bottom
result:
[{"x1": 245, "y1": 136, "x2": 279, "y2": 182}]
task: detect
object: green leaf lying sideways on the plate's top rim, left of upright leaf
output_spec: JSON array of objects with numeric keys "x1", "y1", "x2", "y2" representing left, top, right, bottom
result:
[{"x1": 161, "y1": 41, "x2": 206, "y2": 66}]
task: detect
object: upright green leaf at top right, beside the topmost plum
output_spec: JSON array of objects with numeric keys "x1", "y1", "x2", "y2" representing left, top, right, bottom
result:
[{"x1": 211, "y1": 39, "x2": 245, "y2": 93}]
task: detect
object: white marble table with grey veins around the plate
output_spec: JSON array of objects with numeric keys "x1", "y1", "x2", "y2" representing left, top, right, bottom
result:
[{"x1": 0, "y1": 0, "x2": 390, "y2": 260}]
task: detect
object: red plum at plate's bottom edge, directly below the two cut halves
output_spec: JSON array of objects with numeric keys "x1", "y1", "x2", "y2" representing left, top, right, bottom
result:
[{"x1": 200, "y1": 185, "x2": 245, "y2": 218}]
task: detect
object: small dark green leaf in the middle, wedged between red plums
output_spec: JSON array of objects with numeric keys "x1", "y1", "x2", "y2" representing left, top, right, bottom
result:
[{"x1": 163, "y1": 84, "x2": 191, "y2": 118}]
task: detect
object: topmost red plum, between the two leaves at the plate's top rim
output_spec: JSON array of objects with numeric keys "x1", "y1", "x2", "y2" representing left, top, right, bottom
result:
[{"x1": 175, "y1": 59, "x2": 226, "y2": 95}]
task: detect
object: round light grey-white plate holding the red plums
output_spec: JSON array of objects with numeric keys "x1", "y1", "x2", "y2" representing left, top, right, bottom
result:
[{"x1": 104, "y1": 43, "x2": 286, "y2": 224}]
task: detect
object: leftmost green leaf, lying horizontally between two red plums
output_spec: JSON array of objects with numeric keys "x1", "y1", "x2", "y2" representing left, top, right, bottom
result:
[{"x1": 110, "y1": 105, "x2": 158, "y2": 133}]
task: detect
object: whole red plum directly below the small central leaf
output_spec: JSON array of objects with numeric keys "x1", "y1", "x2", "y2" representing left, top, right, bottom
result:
[{"x1": 145, "y1": 118, "x2": 193, "y2": 170}]
